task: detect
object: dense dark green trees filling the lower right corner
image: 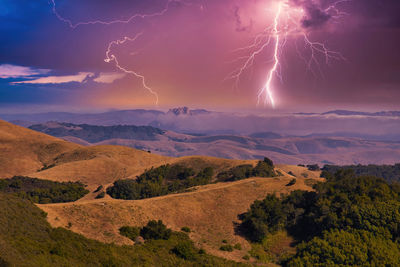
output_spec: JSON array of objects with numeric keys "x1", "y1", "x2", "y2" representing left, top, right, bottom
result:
[{"x1": 238, "y1": 170, "x2": 400, "y2": 266}]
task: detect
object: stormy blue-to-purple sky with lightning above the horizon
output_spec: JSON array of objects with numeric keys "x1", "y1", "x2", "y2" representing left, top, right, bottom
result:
[{"x1": 0, "y1": 0, "x2": 400, "y2": 111}]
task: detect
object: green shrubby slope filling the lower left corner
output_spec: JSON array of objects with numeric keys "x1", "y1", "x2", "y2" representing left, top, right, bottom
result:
[{"x1": 0, "y1": 193, "x2": 247, "y2": 266}]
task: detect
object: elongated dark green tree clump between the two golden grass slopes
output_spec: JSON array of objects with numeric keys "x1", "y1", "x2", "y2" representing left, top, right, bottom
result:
[{"x1": 107, "y1": 158, "x2": 276, "y2": 200}]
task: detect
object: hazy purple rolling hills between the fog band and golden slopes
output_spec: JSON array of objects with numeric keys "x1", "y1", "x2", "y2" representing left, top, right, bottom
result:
[{"x1": 24, "y1": 122, "x2": 400, "y2": 165}]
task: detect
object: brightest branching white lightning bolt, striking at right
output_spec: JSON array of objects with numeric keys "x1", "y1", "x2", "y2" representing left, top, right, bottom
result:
[{"x1": 224, "y1": 0, "x2": 351, "y2": 108}]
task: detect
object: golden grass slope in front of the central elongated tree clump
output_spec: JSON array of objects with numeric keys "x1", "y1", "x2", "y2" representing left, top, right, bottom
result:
[{"x1": 39, "y1": 169, "x2": 321, "y2": 261}]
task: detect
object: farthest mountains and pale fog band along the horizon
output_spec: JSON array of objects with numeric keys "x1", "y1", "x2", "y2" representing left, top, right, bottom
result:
[{"x1": 0, "y1": 107, "x2": 400, "y2": 141}]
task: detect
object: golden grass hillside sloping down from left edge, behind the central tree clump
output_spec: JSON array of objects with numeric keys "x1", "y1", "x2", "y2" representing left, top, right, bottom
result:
[{"x1": 0, "y1": 120, "x2": 255, "y2": 194}]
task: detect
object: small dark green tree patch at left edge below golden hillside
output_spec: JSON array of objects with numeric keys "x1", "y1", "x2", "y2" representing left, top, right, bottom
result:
[{"x1": 0, "y1": 176, "x2": 89, "y2": 204}]
